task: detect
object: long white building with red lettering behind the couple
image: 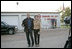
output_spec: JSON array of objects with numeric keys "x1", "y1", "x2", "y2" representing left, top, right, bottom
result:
[{"x1": 1, "y1": 12, "x2": 60, "y2": 30}]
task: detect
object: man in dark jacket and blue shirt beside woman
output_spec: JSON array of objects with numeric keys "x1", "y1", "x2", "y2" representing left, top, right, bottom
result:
[{"x1": 22, "y1": 13, "x2": 34, "y2": 47}]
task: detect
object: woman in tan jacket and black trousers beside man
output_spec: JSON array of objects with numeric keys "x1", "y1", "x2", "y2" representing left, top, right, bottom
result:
[{"x1": 33, "y1": 15, "x2": 40, "y2": 46}]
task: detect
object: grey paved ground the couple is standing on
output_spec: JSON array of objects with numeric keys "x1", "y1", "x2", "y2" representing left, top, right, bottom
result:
[{"x1": 1, "y1": 28, "x2": 69, "y2": 48}]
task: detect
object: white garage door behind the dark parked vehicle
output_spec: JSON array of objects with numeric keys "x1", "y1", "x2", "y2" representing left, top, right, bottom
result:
[{"x1": 1, "y1": 15, "x2": 19, "y2": 28}]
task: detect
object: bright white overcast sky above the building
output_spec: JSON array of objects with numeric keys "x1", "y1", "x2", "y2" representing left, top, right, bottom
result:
[{"x1": 1, "y1": 1, "x2": 71, "y2": 12}]
